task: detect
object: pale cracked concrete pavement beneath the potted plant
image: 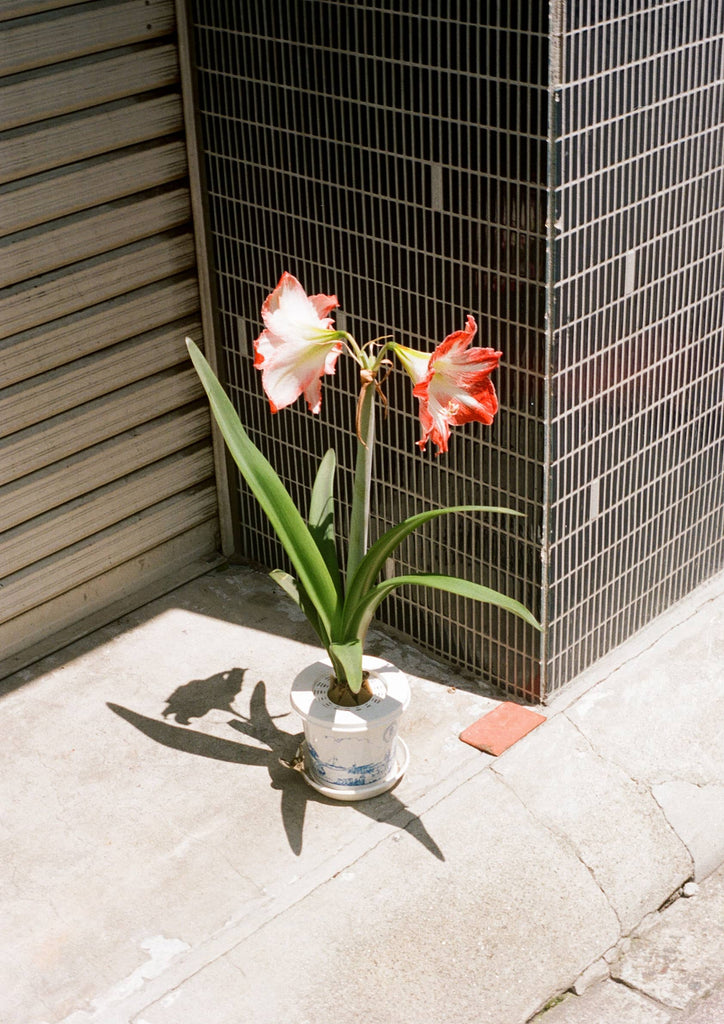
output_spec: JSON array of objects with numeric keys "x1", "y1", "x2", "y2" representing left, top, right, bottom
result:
[{"x1": 0, "y1": 567, "x2": 724, "y2": 1024}]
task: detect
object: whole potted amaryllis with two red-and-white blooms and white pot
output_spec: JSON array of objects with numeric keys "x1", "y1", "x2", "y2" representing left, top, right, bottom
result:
[{"x1": 186, "y1": 273, "x2": 540, "y2": 799}]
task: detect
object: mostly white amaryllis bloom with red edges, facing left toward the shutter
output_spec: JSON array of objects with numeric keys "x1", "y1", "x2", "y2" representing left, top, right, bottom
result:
[{"x1": 254, "y1": 271, "x2": 344, "y2": 413}]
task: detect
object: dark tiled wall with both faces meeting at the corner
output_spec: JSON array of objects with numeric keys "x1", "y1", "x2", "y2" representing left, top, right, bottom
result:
[{"x1": 184, "y1": 0, "x2": 724, "y2": 698}]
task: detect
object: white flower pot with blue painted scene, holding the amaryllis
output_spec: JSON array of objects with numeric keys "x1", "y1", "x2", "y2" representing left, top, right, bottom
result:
[{"x1": 291, "y1": 655, "x2": 410, "y2": 800}]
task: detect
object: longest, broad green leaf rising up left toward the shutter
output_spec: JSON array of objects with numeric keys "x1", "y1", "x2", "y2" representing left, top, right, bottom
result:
[{"x1": 186, "y1": 338, "x2": 339, "y2": 635}]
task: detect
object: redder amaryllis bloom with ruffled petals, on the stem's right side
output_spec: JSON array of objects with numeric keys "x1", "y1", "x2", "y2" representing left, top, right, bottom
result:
[{"x1": 394, "y1": 316, "x2": 503, "y2": 455}]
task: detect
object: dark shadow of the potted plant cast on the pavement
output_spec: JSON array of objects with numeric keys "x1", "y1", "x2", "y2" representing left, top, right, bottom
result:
[{"x1": 108, "y1": 668, "x2": 444, "y2": 860}]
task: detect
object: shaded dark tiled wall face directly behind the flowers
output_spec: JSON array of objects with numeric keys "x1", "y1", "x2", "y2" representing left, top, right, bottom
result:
[{"x1": 191, "y1": 0, "x2": 548, "y2": 696}]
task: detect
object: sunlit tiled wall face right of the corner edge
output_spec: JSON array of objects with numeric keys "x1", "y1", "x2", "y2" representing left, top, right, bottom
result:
[{"x1": 547, "y1": 0, "x2": 724, "y2": 691}]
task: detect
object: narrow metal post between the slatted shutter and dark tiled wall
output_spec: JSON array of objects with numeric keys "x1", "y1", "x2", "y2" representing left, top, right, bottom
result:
[{"x1": 175, "y1": 0, "x2": 238, "y2": 556}]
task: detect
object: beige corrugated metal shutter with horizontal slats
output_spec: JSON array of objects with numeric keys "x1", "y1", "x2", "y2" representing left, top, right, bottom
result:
[{"x1": 0, "y1": 0, "x2": 223, "y2": 675}]
